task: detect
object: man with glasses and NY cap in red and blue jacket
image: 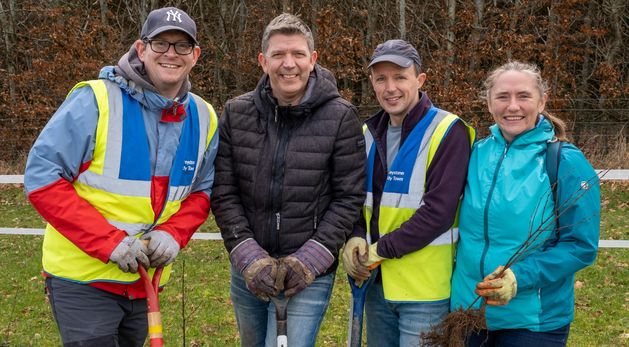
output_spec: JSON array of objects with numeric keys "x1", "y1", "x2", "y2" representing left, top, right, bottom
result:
[{"x1": 24, "y1": 7, "x2": 218, "y2": 346}]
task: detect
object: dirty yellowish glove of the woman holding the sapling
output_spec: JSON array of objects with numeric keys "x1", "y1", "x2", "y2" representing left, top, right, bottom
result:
[{"x1": 475, "y1": 265, "x2": 518, "y2": 306}]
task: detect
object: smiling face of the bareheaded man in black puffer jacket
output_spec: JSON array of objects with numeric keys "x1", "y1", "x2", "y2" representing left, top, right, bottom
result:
[{"x1": 258, "y1": 33, "x2": 317, "y2": 106}]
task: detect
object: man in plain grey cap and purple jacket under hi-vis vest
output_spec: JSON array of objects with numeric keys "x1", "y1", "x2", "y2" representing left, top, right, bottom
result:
[{"x1": 343, "y1": 40, "x2": 474, "y2": 346}]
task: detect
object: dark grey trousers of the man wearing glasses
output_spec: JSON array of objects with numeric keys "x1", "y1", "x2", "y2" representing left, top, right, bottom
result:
[{"x1": 46, "y1": 278, "x2": 148, "y2": 347}]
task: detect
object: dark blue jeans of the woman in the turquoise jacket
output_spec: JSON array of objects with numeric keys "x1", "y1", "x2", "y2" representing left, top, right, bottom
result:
[{"x1": 466, "y1": 324, "x2": 570, "y2": 347}]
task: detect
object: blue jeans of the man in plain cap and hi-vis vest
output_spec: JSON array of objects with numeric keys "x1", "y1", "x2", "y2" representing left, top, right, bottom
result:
[{"x1": 365, "y1": 282, "x2": 450, "y2": 347}]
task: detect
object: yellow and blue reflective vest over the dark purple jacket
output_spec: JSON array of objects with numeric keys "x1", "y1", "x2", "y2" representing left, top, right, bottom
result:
[{"x1": 363, "y1": 107, "x2": 475, "y2": 302}]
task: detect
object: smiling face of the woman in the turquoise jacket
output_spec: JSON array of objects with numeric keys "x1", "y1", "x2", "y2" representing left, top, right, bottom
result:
[{"x1": 487, "y1": 70, "x2": 548, "y2": 142}]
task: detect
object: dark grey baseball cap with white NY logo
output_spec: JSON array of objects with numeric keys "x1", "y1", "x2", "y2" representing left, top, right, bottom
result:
[{"x1": 140, "y1": 7, "x2": 199, "y2": 45}]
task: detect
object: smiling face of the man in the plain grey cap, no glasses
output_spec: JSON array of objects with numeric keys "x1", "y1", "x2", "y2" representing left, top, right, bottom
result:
[{"x1": 370, "y1": 62, "x2": 426, "y2": 126}]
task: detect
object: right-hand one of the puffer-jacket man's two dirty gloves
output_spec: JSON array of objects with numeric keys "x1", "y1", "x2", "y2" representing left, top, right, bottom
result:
[{"x1": 281, "y1": 240, "x2": 334, "y2": 297}]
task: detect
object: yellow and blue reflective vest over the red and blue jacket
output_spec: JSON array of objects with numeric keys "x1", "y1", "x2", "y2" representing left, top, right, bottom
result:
[{"x1": 42, "y1": 80, "x2": 218, "y2": 285}]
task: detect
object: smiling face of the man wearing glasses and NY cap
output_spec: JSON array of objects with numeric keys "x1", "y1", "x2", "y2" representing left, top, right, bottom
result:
[{"x1": 135, "y1": 30, "x2": 201, "y2": 99}]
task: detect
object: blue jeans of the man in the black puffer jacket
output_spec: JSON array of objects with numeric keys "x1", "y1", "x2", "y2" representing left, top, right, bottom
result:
[{"x1": 230, "y1": 266, "x2": 335, "y2": 347}]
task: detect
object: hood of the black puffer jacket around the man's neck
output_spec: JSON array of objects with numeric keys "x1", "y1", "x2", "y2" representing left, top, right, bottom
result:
[{"x1": 254, "y1": 64, "x2": 341, "y2": 116}]
